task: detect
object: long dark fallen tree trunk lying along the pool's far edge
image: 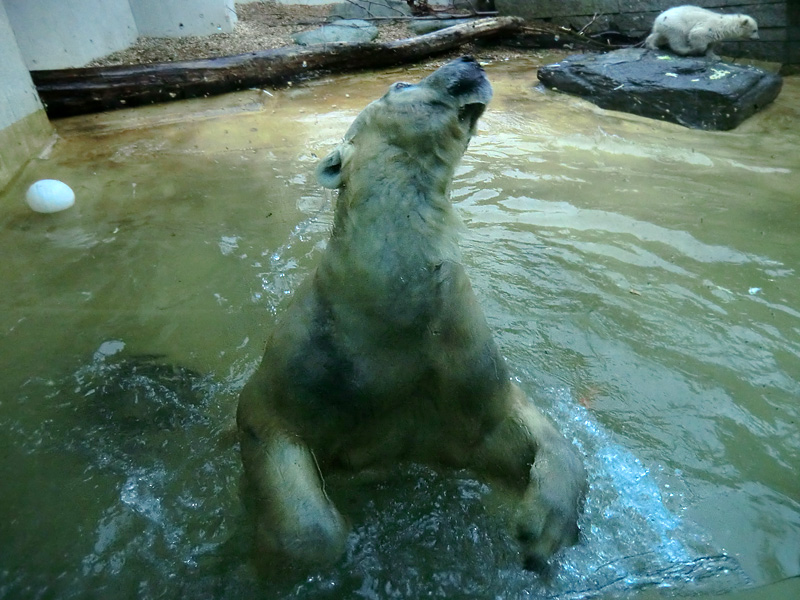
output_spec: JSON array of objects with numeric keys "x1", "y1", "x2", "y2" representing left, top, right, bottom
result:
[{"x1": 31, "y1": 17, "x2": 523, "y2": 118}]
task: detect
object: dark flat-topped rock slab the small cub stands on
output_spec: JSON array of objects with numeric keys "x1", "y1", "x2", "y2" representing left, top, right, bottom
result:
[{"x1": 539, "y1": 48, "x2": 782, "y2": 129}]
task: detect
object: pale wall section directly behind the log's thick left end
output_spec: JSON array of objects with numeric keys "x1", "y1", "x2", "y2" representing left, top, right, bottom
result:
[{"x1": 2, "y1": 0, "x2": 138, "y2": 71}]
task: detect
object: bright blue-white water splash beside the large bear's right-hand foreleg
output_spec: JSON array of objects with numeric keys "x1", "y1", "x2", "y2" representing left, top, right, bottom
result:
[{"x1": 548, "y1": 389, "x2": 747, "y2": 600}]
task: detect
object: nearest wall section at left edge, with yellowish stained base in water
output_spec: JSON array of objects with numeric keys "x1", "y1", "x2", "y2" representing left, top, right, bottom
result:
[{"x1": 0, "y1": 3, "x2": 53, "y2": 190}]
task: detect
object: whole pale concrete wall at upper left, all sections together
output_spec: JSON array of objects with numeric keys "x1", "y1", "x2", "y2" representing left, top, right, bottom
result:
[{"x1": 0, "y1": 0, "x2": 236, "y2": 189}]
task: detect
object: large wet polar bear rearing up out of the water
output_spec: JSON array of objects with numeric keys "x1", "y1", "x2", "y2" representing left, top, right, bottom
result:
[{"x1": 237, "y1": 57, "x2": 586, "y2": 573}]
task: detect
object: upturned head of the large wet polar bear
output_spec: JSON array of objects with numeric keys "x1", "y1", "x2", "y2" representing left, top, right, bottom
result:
[{"x1": 317, "y1": 56, "x2": 492, "y2": 188}]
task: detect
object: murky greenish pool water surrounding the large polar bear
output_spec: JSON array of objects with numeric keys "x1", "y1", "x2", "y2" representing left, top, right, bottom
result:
[{"x1": 0, "y1": 54, "x2": 800, "y2": 600}]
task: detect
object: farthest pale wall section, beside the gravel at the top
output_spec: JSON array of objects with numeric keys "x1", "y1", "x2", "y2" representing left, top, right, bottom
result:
[{"x1": 130, "y1": 0, "x2": 236, "y2": 37}]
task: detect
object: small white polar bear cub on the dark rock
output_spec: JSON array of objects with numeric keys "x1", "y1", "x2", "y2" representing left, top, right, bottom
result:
[{"x1": 644, "y1": 6, "x2": 758, "y2": 60}]
